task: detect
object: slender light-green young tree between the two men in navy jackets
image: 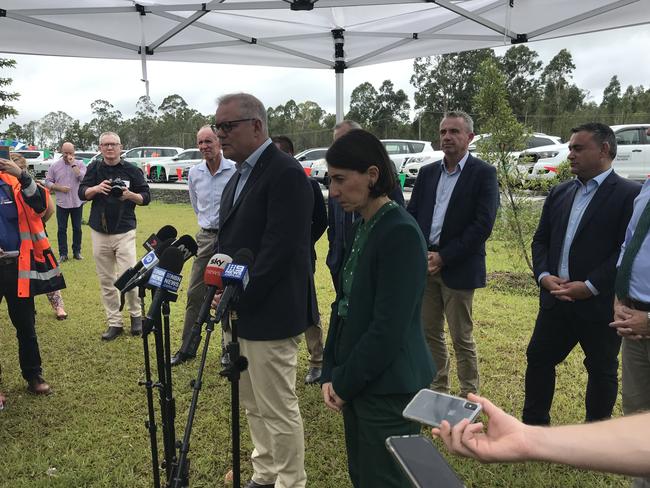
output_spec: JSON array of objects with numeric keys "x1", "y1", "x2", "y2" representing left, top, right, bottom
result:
[{"x1": 474, "y1": 59, "x2": 537, "y2": 272}]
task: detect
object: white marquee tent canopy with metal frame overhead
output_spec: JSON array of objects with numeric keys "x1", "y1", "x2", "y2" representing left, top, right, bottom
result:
[{"x1": 0, "y1": 0, "x2": 650, "y2": 120}]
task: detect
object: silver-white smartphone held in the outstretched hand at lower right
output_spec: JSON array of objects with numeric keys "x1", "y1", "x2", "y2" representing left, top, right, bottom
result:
[{"x1": 402, "y1": 389, "x2": 481, "y2": 427}]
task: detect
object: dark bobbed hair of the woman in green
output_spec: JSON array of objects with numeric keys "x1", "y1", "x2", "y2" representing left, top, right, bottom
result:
[{"x1": 325, "y1": 129, "x2": 397, "y2": 198}]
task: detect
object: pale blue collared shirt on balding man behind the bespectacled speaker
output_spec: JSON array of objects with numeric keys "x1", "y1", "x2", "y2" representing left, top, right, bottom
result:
[{"x1": 187, "y1": 156, "x2": 236, "y2": 229}]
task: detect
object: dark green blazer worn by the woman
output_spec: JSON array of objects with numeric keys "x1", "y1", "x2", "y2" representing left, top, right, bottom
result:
[{"x1": 321, "y1": 207, "x2": 435, "y2": 401}]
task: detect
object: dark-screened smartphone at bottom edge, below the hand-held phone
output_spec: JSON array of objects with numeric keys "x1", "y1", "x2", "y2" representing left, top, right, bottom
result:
[{"x1": 386, "y1": 435, "x2": 465, "y2": 488}]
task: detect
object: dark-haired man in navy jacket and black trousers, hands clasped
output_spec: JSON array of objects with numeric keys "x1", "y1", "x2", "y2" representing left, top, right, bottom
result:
[{"x1": 523, "y1": 123, "x2": 641, "y2": 425}]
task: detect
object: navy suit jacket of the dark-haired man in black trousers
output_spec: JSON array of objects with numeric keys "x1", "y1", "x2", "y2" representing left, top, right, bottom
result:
[{"x1": 532, "y1": 172, "x2": 641, "y2": 322}]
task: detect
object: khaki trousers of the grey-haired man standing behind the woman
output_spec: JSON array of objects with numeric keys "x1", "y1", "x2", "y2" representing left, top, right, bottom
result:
[{"x1": 422, "y1": 273, "x2": 479, "y2": 396}]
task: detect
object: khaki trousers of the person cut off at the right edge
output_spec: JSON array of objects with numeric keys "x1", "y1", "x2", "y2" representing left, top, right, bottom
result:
[{"x1": 622, "y1": 338, "x2": 650, "y2": 488}]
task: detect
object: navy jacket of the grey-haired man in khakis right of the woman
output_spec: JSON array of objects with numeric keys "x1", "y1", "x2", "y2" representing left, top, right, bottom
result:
[{"x1": 407, "y1": 154, "x2": 499, "y2": 290}]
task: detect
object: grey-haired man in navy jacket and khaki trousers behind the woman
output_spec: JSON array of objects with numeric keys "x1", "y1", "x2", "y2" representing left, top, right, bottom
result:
[{"x1": 407, "y1": 111, "x2": 499, "y2": 396}]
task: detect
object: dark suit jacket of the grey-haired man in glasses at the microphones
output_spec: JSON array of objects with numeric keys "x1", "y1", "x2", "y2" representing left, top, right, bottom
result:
[{"x1": 217, "y1": 144, "x2": 314, "y2": 340}]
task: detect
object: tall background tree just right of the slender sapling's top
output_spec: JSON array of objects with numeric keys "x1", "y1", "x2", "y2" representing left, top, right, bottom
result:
[{"x1": 499, "y1": 44, "x2": 542, "y2": 122}]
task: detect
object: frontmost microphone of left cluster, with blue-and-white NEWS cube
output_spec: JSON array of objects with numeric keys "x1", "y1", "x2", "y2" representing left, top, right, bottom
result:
[{"x1": 142, "y1": 246, "x2": 183, "y2": 336}]
